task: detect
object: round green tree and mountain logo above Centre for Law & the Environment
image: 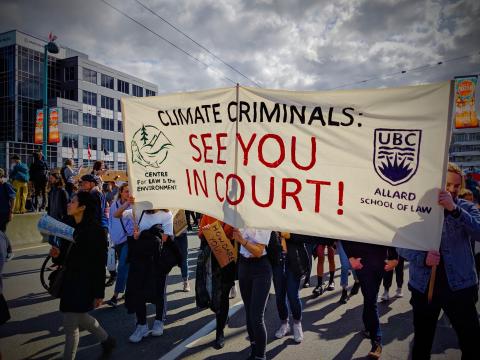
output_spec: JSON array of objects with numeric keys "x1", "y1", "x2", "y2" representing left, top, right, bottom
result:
[{"x1": 131, "y1": 125, "x2": 173, "y2": 168}]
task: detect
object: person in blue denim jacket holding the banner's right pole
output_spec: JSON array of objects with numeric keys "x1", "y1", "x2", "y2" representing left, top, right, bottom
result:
[{"x1": 398, "y1": 163, "x2": 480, "y2": 359}]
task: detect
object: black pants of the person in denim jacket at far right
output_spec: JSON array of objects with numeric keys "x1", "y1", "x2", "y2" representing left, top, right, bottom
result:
[{"x1": 409, "y1": 286, "x2": 480, "y2": 360}]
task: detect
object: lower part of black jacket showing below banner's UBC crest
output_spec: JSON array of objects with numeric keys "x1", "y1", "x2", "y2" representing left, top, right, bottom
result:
[{"x1": 342, "y1": 240, "x2": 398, "y2": 271}]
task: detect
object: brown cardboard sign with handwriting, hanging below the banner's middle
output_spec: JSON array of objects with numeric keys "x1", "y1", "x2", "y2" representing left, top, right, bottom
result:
[{"x1": 202, "y1": 221, "x2": 237, "y2": 268}]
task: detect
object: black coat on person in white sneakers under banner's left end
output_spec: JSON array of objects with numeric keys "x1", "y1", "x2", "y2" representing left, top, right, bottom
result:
[{"x1": 125, "y1": 225, "x2": 182, "y2": 313}]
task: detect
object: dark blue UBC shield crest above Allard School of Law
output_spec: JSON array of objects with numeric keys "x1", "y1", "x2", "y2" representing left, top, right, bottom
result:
[{"x1": 373, "y1": 129, "x2": 422, "y2": 186}]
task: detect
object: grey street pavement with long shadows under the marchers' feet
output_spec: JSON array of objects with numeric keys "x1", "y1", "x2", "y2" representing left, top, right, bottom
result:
[{"x1": 0, "y1": 235, "x2": 476, "y2": 360}]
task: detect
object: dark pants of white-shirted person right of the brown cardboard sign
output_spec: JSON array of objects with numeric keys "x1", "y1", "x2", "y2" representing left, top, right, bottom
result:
[{"x1": 238, "y1": 256, "x2": 272, "y2": 359}]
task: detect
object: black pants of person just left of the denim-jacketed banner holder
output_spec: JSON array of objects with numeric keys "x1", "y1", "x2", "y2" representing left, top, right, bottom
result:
[{"x1": 356, "y1": 264, "x2": 385, "y2": 344}]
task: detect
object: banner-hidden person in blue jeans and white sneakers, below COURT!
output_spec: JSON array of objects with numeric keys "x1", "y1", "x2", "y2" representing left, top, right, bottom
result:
[{"x1": 272, "y1": 232, "x2": 309, "y2": 343}]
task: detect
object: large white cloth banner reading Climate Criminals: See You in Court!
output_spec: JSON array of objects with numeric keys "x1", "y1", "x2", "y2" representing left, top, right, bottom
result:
[{"x1": 122, "y1": 82, "x2": 451, "y2": 250}]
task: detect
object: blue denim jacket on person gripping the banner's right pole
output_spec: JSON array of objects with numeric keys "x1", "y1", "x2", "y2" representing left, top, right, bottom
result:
[{"x1": 398, "y1": 199, "x2": 480, "y2": 293}]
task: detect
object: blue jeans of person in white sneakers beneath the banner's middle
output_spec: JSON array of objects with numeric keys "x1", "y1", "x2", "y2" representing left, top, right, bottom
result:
[{"x1": 272, "y1": 260, "x2": 302, "y2": 321}]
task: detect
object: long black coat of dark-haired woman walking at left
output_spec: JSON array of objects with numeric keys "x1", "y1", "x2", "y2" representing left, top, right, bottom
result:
[{"x1": 58, "y1": 222, "x2": 108, "y2": 313}]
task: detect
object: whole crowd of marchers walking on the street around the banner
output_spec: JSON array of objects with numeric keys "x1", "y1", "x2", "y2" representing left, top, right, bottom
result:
[{"x1": 0, "y1": 154, "x2": 480, "y2": 359}]
